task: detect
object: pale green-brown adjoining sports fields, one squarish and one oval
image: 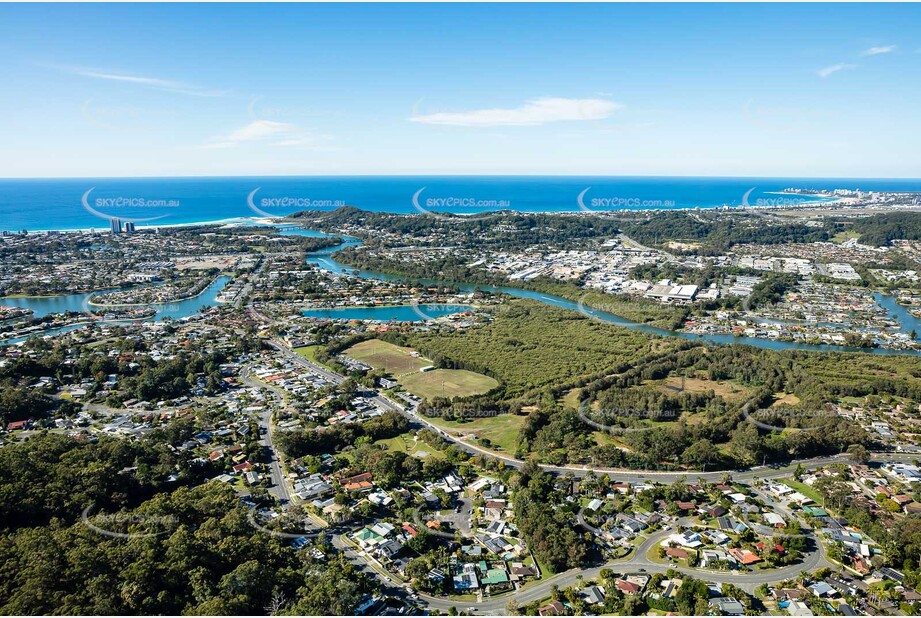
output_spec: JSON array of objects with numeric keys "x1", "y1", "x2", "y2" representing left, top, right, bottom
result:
[{"x1": 343, "y1": 339, "x2": 499, "y2": 399}]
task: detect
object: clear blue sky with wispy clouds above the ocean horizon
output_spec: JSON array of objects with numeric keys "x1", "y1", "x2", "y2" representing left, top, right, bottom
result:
[{"x1": 0, "y1": 4, "x2": 921, "y2": 178}]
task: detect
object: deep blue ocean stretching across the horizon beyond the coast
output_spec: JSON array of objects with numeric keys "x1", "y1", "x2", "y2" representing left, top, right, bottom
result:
[{"x1": 0, "y1": 176, "x2": 921, "y2": 231}]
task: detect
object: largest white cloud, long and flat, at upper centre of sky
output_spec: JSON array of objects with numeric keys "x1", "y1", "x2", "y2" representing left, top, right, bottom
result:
[{"x1": 410, "y1": 97, "x2": 623, "y2": 127}]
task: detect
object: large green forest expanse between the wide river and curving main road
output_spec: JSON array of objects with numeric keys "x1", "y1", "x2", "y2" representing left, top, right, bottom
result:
[{"x1": 364, "y1": 299, "x2": 921, "y2": 470}]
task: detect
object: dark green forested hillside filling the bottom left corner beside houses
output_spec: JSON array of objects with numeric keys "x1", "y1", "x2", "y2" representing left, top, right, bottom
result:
[{"x1": 0, "y1": 434, "x2": 373, "y2": 615}]
